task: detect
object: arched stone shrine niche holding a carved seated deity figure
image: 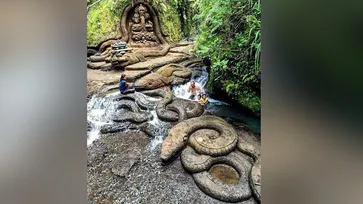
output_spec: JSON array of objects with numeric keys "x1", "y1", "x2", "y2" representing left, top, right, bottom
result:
[{"x1": 121, "y1": 1, "x2": 166, "y2": 47}]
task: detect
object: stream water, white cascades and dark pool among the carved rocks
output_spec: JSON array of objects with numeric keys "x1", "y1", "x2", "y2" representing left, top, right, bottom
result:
[{"x1": 87, "y1": 67, "x2": 260, "y2": 151}]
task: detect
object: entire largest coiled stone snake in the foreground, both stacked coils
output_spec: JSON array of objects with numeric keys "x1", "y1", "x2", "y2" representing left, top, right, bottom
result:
[{"x1": 160, "y1": 115, "x2": 261, "y2": 202}]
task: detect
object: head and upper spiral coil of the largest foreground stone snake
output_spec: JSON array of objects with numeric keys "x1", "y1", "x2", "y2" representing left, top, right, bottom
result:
[{"x1": 160, "y1": 115, "x2": 238, "y2": 161}]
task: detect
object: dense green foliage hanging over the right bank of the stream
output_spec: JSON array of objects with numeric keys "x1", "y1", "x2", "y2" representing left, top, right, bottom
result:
[{"x1": 193, "y1": 0, "x2": 261, "y2": 112}]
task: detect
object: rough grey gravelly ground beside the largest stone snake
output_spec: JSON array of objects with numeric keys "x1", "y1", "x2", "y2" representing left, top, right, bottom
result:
[{"x1": 87, "y1": 125, "x2": 256, "y2": 204}]
